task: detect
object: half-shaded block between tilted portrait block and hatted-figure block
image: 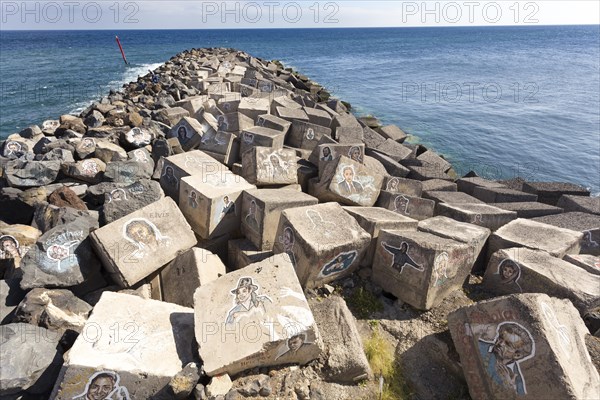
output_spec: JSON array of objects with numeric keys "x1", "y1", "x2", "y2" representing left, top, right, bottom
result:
[{"x1": 160, "y1": 247, "x2": 227, "y2": 308}]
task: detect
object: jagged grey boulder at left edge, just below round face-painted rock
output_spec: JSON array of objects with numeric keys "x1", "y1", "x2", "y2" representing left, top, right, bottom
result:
[{"x1": 4, "y1": 160, "x2": 60, "y2": 188}]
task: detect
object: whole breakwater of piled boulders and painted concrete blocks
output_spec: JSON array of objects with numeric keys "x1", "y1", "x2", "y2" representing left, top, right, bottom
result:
[{"x1": 0, "y1": 48, "x2": 600, "y2": 400}]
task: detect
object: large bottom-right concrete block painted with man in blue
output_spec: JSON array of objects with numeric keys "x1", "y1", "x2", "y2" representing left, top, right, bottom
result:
[{"x1": 448, "y1": 294, "x2": 600, "y2": 400}]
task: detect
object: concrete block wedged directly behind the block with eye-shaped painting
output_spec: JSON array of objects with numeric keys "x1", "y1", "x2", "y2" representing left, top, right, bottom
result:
[{"x1": 241, "y1": 189, "x2": 319, "y2": 250}]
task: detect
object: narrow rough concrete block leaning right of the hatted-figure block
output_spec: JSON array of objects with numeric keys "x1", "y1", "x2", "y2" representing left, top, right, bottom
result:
[{"x1": 310, "y1": 296, "x2": 373, "y2": 384}]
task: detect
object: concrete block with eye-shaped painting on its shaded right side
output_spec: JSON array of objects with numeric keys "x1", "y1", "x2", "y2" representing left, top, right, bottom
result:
[{"x1": 273, "y1": 203, "x2": 371, "y2": 288}]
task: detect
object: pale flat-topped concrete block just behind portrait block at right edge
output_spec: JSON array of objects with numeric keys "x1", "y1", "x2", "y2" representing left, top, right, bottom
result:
[{"x1": 489, "y1": 218, "x2": 583, "y2": 258}]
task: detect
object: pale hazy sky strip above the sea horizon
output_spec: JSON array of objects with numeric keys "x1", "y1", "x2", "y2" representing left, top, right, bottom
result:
[{"x1": 0, "y1": 0, "x2": 600, "y2": 30}]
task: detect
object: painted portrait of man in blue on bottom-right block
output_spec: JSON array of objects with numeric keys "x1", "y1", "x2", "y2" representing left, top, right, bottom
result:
[{"x1": 465, "y1": 321, "x2": 535, "y2": 396}]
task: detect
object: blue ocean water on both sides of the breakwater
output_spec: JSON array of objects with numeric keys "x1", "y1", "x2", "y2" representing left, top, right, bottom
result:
[{"x1": 0, "y1": 26, "x2": 600, "y2": 193}]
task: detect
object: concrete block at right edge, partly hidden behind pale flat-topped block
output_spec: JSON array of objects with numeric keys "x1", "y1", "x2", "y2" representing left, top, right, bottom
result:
[{"x1": 533, "y1": 212, "x2": 600, "y2": 256}]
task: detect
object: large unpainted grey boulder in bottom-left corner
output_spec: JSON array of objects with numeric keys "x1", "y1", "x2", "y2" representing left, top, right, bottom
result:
[{"x1": 0, "y1": 323, "x2": 62, "y2": 398}]
